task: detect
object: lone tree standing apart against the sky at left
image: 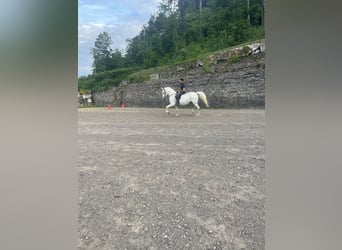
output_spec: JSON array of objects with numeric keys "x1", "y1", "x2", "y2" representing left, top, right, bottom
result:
[{"x1": 91, "y1": 32, "x2": 113, "y2": 73}]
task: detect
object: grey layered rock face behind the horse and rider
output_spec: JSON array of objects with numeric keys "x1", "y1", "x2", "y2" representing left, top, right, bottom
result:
[{"x1": 93, "y1": 52, "x2": 265, "y2": 108}]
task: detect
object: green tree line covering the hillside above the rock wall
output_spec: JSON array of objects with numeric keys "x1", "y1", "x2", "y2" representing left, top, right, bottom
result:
[{"x1": 79, "y1": 0, "x2": 265, "y2": 90}]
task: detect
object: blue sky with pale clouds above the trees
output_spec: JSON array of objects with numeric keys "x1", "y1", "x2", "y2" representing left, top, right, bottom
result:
[{"x1": 78, "y1": 0, "x2": 162, "y2": 76}]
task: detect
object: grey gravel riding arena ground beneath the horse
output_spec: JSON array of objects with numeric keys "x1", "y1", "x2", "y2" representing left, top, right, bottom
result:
[{"x1": 78, "y1": 108, "x2": 265, "y2": 250}]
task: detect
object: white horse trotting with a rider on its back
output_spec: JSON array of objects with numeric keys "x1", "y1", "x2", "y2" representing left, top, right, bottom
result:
[{"x1": 161, "y1": 87, "x2": 209, "y2": 116}]
